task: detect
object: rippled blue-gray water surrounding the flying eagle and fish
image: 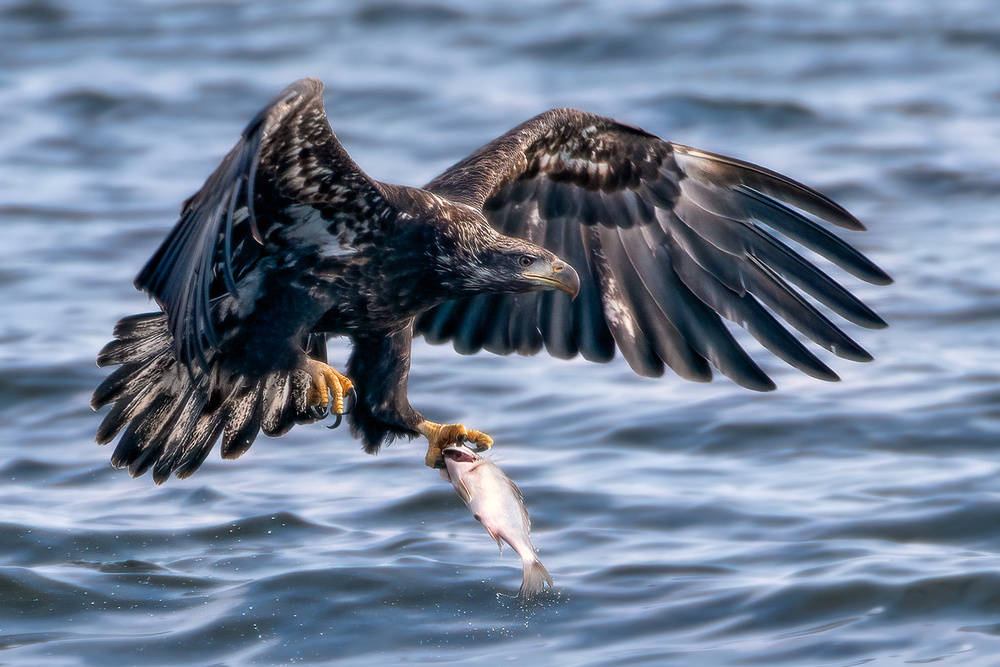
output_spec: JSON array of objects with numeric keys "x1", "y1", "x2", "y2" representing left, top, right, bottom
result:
[{"x1": 0, "y1": 0, "x2": 1000, "y2": 666}]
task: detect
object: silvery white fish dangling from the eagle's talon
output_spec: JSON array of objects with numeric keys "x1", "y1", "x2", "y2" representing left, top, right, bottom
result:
[{"x1": 441, "y1": 444, "x2": 553, "y2": 600}]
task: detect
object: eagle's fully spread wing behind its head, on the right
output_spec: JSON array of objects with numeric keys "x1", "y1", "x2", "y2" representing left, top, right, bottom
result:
[{"x1": 416, "y1": 109, "x2": 892, "y2": 390}]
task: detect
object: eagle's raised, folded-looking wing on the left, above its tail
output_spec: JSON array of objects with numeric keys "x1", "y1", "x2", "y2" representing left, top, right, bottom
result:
[{"x1": 135, "y1": 79, "x2": 384, "y2": 374}]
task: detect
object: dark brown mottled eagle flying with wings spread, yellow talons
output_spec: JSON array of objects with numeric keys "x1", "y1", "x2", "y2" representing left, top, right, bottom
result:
[{"x1": 91, "y1": 78, "x2": 891, "y2": 483}]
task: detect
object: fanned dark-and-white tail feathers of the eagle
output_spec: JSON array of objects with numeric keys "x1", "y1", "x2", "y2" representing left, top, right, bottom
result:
[{"x1": 90, "y1": 313, "x2": 311, "y2": 484}]
